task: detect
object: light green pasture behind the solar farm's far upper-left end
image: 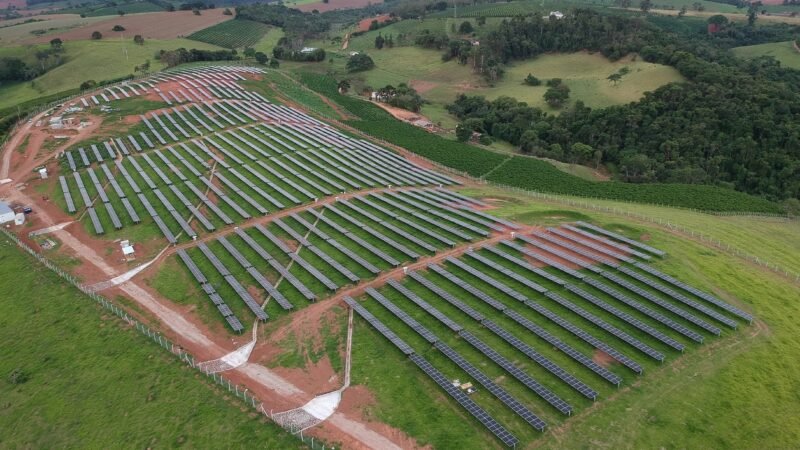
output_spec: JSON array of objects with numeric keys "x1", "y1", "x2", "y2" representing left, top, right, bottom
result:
[{"x1": 0, "y1": 39, "x2": 219, "y2": 108}]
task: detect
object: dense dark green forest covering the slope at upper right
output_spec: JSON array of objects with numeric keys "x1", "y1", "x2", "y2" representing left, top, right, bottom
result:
[{"x1": 449, "y1": 10, "x2": 800, "y2": 199}]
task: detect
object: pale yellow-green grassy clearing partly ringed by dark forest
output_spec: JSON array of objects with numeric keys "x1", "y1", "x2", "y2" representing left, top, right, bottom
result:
[{"x1": 308, "y1": 24, "x2": 683, "y2": 120}]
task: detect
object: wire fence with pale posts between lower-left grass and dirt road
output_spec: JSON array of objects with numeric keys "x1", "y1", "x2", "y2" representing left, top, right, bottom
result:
[{"x1": 0, "y1": 228, "x2": 335, "y2": 450}]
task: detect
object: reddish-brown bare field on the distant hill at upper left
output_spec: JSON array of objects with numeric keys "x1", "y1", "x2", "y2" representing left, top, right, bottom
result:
[{"x1": 29, "y1": 8, "x2": 233, "y2": 43}]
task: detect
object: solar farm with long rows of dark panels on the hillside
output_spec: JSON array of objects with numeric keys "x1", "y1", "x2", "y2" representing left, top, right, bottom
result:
[{"x1": 32, "y1": 66, "x2": 754, "y2": 447}]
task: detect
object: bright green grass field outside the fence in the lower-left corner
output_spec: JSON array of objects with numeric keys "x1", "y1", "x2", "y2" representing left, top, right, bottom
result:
[{"x1": 0, "y1": 239, "x2": 299, "y2": 448}]
